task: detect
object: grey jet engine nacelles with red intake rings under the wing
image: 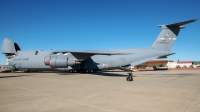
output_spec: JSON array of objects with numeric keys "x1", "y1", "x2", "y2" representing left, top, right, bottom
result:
[{"x1": 44, "y1": 55, "x2": 81, "y2": 68}]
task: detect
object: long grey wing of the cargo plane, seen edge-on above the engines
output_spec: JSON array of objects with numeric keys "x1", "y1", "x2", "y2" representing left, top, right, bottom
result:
[{"x1": 53, "y1": 50, "x2": 133, "y2": 61}]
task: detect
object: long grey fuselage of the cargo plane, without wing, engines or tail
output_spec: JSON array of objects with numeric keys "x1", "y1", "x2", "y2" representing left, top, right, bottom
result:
[{"x1": 8, "y1": 48, "x2": 170, "y2": 70}]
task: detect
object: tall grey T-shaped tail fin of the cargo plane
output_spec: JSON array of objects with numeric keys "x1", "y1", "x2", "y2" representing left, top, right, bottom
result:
[{"x1": 151, "y1": 19, "x2": 197, "y2": 51}]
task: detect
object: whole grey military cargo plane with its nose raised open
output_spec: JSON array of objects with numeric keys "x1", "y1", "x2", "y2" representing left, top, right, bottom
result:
[{"x1": 2, "y1": 19, "x2": 197, "y2": 81}]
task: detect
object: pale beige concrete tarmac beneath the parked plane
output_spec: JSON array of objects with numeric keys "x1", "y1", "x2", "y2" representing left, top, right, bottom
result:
[{"x1": 0, "y1": 71, "x2": 200, "y2": 112}]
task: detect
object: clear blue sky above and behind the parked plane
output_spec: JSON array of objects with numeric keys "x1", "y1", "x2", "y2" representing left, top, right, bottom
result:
[{"x1": 0, "y1": 0, "x2": 200, "y2": 65}]
